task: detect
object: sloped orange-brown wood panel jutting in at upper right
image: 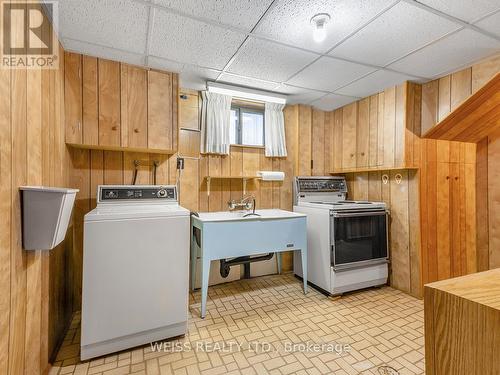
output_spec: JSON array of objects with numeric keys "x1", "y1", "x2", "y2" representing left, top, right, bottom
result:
[{"x1": 423, "y1": 73, "x2": 500, "y2": 142}]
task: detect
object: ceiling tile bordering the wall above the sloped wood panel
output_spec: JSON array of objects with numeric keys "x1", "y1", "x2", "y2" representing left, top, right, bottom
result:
[{"x1": 389, "y1": 29, "x2": 500, "y2": 78}]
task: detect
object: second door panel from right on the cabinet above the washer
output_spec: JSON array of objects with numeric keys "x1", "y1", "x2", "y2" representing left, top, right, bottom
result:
[{"x1": 121, "y1": 64, "x2": 148, "y2": 148}]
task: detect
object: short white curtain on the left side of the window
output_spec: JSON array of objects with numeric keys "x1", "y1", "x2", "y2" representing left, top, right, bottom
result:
[{"x1": 201, "y1": 91, "x2": 232, "y2": 155}]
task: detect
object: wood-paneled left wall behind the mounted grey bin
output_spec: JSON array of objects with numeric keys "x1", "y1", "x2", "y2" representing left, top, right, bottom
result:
[{"x1": 0, "y1": 3, "x2": 72, "y2": 374}]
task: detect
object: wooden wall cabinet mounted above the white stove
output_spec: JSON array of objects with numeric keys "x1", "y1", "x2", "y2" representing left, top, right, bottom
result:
[{"x1": 328, "y1": 82, "x2": 421, "y2": 173}]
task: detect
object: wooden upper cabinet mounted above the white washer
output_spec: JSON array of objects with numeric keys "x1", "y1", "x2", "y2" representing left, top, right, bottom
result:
[{"x1": 65, "y1": 52, "x2": 178, "y2": 153}]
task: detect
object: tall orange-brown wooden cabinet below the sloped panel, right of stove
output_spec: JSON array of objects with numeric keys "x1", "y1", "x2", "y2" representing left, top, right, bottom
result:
[{"x1": 420, "y1": 148, "x2": 476, "y2": 283}]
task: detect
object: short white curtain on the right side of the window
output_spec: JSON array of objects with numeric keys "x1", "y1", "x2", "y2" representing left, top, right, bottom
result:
[{"x1": 264, "y1": 102, "x2": 286, "y2": 157}]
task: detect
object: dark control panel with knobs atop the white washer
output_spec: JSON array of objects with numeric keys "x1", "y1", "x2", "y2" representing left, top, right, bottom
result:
[{"x1": 98, "y1": 185, "x2": 177, "y2": 202}]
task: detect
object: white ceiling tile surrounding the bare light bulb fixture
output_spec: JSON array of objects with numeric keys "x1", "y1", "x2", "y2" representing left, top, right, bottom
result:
[{"x1": 255, "y1": 0, "x2": 395, "y2": 52}]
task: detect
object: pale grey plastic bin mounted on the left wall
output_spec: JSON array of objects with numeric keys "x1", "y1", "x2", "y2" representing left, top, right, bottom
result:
[{"x1": 20, "y1": 186, "x2": 79, "y2": 250}]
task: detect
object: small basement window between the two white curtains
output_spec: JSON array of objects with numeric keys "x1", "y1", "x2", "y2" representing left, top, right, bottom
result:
[{"x1": 230, "y1": 106, "x2": 264, "y2": 146}]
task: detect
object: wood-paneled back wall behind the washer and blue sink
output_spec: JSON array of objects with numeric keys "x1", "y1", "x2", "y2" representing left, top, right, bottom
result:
[{"x1": 66, "y1": 86, "x2": 299, "y2": 310}]
